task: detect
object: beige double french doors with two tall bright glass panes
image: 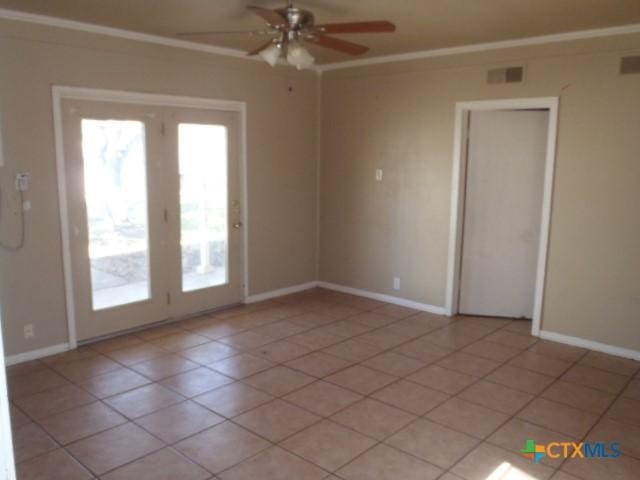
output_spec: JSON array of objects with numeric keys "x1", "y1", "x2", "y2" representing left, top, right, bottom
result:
[{"x1": 62, "y1": 100, "x2": 243, "y2": 341}]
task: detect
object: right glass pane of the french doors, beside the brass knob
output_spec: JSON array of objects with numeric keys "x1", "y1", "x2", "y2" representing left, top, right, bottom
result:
[{"x1": 178, "y1": 123, "x2": 229, "y2": 292}]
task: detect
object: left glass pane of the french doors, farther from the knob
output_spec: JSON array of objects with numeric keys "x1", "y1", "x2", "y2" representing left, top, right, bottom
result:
[{"x1": 81, "y1": 119, "x2": 150, "y2": 310}]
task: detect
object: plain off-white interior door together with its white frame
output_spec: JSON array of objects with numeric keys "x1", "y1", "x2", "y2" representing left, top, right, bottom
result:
[{"x1": 446, "y1": 97, "x2": 558, "y2": 336}]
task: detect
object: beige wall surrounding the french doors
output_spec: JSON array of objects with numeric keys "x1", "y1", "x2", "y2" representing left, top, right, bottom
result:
[{"x1": 0, "y1": 21, "x2": 318, "y2": 355}]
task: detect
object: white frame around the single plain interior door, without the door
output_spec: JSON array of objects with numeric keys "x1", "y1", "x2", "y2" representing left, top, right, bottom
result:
[{"x1": 446, "y1": 97, "x2": 559, "y2": 336}]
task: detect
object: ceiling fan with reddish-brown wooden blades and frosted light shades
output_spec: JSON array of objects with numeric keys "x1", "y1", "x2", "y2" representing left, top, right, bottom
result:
[{"x1": 178, "y1": 1, "x2": 396, "y2": 70}]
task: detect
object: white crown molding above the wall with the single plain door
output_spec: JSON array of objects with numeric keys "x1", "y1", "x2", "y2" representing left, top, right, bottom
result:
[{"x1": 317, "y1": 23, "x2": 640, "y2": 73}]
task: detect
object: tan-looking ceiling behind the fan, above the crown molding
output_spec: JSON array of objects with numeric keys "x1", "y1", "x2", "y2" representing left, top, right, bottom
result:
[{"x1": 0, "y1": 0, "x2": 640, "y2": 64}]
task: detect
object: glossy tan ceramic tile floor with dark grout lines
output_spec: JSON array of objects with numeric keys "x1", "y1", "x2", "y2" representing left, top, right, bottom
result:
[{"x1": 8, "y1": 289, "x2": 640, "y2": 480}]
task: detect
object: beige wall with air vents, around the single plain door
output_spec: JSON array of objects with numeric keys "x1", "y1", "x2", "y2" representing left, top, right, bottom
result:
[{"x1": 320, "y1": 35, "x2": 640, "y2": 350}]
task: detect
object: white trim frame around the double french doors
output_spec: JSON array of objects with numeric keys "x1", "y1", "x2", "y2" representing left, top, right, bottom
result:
[{"x1": 52, "y1": 86, "x2": 249, "y2": 349}]
